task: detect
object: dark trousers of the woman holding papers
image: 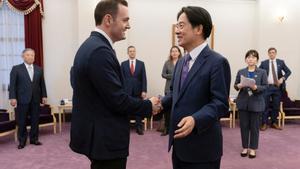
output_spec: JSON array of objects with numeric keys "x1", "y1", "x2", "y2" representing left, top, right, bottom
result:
[{"x1": 239, "y1": 110, "x2": 261, "y2": 150}]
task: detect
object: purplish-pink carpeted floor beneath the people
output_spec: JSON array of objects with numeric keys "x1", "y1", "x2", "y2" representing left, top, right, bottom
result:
[{"x1": 0, "y1": 121, "x2": 300, "y2": 169}]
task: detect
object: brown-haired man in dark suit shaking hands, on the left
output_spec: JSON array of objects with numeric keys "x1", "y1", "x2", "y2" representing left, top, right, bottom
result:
[{"x1": 70, "y1": 0, "x2": 159, "y2": 169}]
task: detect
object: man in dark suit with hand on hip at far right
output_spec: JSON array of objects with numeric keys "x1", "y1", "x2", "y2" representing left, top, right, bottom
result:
[{"x1": 259, "y1": 47, "x2": 291, "y2": 131}]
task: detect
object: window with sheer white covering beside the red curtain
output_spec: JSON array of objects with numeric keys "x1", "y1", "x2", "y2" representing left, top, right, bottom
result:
[{"x1": 0, "y1": 3, "x2": 25, "y2": 109}]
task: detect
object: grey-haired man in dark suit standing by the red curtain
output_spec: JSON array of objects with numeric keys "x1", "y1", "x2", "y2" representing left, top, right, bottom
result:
[{"x1": 9, "y1": 48, "x2": 47, "y2": 149}]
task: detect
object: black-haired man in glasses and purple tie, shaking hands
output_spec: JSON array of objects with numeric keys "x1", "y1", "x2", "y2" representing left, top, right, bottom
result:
[{"x1": 162, "y1": 6, "x2": 231, "y2": 169}]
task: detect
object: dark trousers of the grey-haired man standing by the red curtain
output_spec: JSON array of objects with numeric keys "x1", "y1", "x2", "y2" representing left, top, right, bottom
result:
[{"x1": 15, "y1": 102, "x2": 40, "y2": 144}]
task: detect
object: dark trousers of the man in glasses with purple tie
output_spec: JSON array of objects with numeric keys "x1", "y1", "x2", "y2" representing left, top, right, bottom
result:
[{"x1": 172, "y1": 151, "x2": 221, "y2": 169}]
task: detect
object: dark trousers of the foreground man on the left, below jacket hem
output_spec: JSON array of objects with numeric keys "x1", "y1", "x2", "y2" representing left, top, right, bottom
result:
[{"x1": 90, "y1": 158, "x2": 127, "y2": 169}]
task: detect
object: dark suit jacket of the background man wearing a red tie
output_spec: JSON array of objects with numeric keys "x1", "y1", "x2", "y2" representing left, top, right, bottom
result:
[{"x1": 121, "y1": 59, "x2": 147, "y2": 96}]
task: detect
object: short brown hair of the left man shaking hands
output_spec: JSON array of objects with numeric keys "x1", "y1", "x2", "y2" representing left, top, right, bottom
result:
[{"x1": 94, "y1": 0, "x2": 128, "y2": 25}]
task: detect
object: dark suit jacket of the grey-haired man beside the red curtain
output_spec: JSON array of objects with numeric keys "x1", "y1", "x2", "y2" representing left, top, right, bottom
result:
[{"x1": 9, "y1": 63, "x2": 47, "y2": 104}]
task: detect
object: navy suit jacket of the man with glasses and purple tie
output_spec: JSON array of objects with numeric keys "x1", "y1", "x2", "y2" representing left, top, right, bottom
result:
[{"x1": 162, "y1": 46, "x2": 231, "y2": 163}]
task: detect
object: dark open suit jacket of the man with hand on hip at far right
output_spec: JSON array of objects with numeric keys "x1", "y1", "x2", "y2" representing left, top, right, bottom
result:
[{"x1": 259, "y1": 59, "x2": 292, "y2": 91}]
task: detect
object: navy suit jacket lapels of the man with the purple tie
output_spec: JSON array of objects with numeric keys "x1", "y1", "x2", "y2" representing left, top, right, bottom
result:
[{"x1": 178, "y1": 46, "x2": 210, "y2": 100}]
